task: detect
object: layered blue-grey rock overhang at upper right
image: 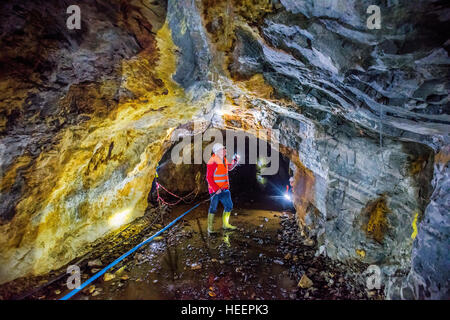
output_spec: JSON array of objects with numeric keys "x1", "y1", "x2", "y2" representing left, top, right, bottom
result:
[{"x1": 232, "y1": 0, "x2": 449, "y2": 142}]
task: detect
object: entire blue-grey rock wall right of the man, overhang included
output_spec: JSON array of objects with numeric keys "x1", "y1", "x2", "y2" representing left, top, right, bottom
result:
[{"x1": 200, "y1": 0, "x2": 450, "y2": 298}]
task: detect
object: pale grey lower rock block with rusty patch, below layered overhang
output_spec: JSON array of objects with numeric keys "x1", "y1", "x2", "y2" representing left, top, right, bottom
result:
[{"x1": 218, "y1": 98, "x2": 433, "y2": 270}]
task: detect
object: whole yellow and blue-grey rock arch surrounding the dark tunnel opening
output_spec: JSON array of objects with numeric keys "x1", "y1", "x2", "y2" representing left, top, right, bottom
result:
[{"x1": 0, "y1": 0, "x2": 450, "y2": 298}]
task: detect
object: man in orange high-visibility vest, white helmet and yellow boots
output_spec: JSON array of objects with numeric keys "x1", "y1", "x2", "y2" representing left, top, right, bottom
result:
[{"x1": 206, "y1": 143, "x2": 239, "y2": 234}]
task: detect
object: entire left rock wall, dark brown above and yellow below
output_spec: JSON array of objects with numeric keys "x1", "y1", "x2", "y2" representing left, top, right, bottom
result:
[{"x1": 0, "y1": 1, "x2": 216, "y2": 283}]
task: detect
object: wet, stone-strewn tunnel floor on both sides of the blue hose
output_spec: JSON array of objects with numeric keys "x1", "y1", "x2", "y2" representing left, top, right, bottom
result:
[{"x1": 0, "y1": 202, "x2": 384, "y2": 300}]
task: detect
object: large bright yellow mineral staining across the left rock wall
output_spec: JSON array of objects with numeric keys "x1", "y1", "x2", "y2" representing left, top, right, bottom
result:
[{"x1": 0, "y1": 23, "x2": 213, "y2": 283}]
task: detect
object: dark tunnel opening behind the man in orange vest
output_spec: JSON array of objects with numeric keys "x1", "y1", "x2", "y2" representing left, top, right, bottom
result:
[{"x1": 149, "y1": 130, "x2": 294, "y2": 211}]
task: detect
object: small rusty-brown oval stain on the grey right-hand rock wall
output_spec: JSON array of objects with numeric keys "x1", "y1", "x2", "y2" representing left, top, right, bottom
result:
[{"x1": 364, "y1": 197, "x2": 390, "y2": 243}]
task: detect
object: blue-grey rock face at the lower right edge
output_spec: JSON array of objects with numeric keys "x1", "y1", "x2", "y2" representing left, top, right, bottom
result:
[{"x1": 387, "y1": 147, "x2": 450, "y2": 299}]
